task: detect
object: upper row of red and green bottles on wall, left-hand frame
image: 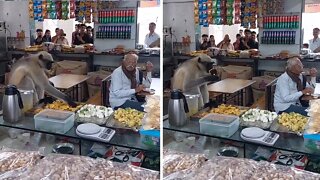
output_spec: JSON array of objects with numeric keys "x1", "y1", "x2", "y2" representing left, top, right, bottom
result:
[{"x1": 98, "y1": 10, "x2": 135, "y2": 24}]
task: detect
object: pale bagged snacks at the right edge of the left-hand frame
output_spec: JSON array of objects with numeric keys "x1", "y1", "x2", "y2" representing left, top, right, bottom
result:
[{"x1": 143, "y1": 96, "x2": 160, "y2": 130}]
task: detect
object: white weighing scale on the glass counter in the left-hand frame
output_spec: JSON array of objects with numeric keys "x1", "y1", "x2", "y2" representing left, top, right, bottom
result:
[{"x1": 76, "y1": 123, "x2": 116, "y2": 142}]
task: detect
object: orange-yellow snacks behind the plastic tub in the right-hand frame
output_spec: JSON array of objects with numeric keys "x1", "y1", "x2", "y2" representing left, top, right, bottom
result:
[{"x1": 192, "y1": 104, "x2": 249, "y2": 118}]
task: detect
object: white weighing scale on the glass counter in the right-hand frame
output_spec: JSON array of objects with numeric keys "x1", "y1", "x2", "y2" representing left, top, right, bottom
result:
[{"x1": 240, "y1": 127, "x2": 279, "y2": 146}]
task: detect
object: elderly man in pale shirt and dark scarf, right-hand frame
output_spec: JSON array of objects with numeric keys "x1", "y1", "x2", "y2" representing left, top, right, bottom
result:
[{"x1": 274, "y1": 57, "x2": 317, "y2": 116}]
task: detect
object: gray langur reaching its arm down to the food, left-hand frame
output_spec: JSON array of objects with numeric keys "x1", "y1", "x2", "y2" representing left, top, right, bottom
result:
[{"x1": 9, "y1": 51, "x2": 76, "y2": 107}]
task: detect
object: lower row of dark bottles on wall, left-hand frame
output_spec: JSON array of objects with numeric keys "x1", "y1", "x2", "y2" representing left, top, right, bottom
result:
[{"x1": 96, "y1": 26, "x2": 131, "y2": 39}]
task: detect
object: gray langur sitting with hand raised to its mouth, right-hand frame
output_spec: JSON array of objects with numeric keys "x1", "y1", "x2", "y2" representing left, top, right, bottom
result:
[{"x1": 172, "y1": 54, "x2": 219, "y2": 108}]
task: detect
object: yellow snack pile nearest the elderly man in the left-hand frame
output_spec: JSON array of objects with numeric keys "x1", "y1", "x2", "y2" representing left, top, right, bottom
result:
[{"x1": 106, "y1": 108, "x2": 145, "y2": 131}]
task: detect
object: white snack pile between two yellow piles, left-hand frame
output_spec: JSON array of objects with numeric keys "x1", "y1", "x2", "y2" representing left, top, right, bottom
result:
[{"x1": 77, "y1": 104, "x2": 113, "y2": 118}]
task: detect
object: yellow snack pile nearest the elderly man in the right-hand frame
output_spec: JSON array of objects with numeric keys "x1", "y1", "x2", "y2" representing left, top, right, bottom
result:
[{"x1": 270, "y1": 112, "x2": 309, "y2": 134}]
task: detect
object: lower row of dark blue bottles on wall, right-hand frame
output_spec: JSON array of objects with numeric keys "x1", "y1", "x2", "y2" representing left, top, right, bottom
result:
[{"x1": 261, "y1": 31, "x2": 296, "y2": 44}]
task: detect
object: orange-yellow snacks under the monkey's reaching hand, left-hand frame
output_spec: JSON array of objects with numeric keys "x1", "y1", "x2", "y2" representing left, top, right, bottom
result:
[{"x1": 25, "y1": 100, "x2": 85, "y2": 116}]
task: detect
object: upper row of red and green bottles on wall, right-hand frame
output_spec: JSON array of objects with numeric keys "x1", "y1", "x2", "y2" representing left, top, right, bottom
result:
[{"x1": 263, "y1": 15, "x2": 299, "y2": 29}]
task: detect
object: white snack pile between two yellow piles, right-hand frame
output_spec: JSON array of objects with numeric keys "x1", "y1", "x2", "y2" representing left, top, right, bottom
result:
[{"x1": 241, "y1": 109, "x2": 278, "y2": 123}]
